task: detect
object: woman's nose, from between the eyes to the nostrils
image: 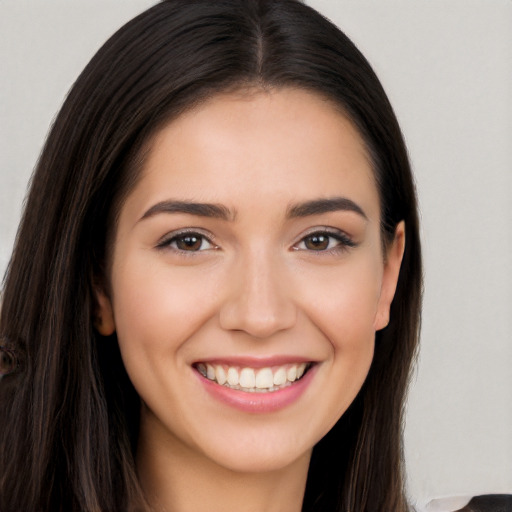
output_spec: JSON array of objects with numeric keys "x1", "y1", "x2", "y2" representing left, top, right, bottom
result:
[{"x1": 220, "y1": 251, "x2": 297, "y2": 338}]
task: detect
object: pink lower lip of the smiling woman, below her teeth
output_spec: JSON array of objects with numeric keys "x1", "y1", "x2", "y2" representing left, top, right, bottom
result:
[{"x1": 196, "y1": 365, "x2": 317, "y2": 413}]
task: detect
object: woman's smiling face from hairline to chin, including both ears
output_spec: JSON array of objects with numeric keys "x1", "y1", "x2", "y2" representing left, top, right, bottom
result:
[{"x1": 98, "y1": 89, "x2": 404, "y2": 471}]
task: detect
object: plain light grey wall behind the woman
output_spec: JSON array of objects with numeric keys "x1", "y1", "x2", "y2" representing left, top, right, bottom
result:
[{"x1": 0, "y1": 0, "x2": 512, "y2": 503}]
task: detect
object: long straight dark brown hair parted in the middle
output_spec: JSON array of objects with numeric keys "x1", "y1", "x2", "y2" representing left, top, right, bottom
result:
[{"x1": 0, "y1": 0, "x2": 421, "y2": 512}]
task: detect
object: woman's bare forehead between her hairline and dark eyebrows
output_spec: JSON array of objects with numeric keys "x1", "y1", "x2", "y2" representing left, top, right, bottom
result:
[{"x1": 120, "y1": 89, "x2": 379, "y2": 223}]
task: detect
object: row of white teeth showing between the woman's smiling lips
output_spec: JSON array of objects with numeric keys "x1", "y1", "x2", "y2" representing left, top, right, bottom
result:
[{"x1": 194, "y1": 363, "x2": 313, "y2": 393}]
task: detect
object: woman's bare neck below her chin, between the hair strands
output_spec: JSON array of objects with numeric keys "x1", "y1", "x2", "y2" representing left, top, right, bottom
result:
[{"x1": 137, "y1": 416, "x2": 311, "y2": 512}]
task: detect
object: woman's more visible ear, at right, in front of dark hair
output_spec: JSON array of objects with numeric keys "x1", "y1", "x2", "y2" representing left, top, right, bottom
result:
[{"x1": 374, "y1": 221, "x2": 405, "y2": 331}]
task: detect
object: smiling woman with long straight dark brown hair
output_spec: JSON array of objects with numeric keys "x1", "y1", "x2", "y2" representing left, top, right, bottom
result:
[{"x1": 0, "y1": 0, "x2": 421, "y2": 512}]
